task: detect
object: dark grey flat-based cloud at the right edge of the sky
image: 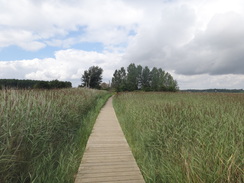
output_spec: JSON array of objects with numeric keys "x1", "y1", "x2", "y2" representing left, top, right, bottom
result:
[{"x1": 174, "y1": 13, "x2": 244, "y2": 75}]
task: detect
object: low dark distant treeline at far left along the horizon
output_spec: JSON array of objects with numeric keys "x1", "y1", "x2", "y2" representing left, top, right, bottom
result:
[{"x1": 0, "y1": 79, "x2": 72, "y2": 89}]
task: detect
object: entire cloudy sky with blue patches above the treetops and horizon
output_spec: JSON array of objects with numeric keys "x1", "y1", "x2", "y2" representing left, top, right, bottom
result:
[{"x1": 0, "y1": 0, "x2": 244, "y2": 89}]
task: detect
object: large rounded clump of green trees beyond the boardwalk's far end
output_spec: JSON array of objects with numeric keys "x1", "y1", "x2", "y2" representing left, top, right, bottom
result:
[{"x1": 112, "y1": 63, "x2": 179, "y2": 92}]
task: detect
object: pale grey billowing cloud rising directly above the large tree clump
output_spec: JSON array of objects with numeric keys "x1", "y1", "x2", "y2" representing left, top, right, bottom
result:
[{"x1": 124, "y1": 4, "x2": 196, "y2": 66}]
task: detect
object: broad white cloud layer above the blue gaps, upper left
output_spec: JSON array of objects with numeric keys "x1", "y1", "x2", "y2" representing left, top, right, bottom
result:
[{"x1": 0, "y1": 0, "x2": 141, "y2": 50}]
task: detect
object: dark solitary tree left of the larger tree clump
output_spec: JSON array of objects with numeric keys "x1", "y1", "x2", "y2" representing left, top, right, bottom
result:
[{"x1": 81, "y1": 66, "x2": 103, "y2": 89}]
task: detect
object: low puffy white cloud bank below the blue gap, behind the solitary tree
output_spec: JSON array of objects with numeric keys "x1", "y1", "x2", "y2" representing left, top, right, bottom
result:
[{"x1": 0, "y1": 49, "x2": 121, "y2": 86}]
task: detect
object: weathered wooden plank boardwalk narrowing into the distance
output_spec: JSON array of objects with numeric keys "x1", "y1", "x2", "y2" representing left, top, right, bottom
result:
[{"x1": 75, "y1": 98, "x2": 144, "y2": 183}]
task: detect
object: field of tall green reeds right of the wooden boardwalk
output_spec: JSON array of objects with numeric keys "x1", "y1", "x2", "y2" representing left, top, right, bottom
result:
[{"x1": 113, "y1": 92, "x2": 244, "y2": 183}]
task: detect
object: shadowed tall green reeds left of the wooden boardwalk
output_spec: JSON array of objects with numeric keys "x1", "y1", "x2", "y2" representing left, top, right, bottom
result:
[{"x1": 0, "y1": 89, "x2": 110, "y2": 183}]
